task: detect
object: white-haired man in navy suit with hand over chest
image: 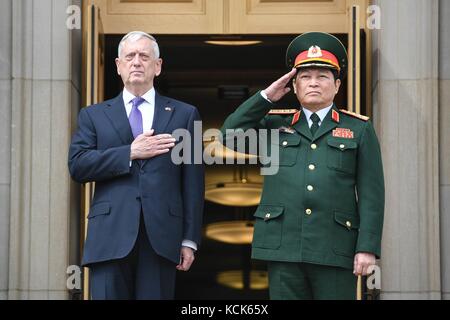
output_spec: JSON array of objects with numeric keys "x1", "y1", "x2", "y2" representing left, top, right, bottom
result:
[{"x1": 69, "y1": 31, "x2": 204, "y2": 299}]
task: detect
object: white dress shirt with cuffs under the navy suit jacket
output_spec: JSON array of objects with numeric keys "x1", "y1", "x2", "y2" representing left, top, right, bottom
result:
[{"x1": 122, "y1": 88, "x2": 197, "y2": 251}]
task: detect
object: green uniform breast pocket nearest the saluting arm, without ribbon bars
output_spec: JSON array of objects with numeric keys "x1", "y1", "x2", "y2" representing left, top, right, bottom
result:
[{"x1": 271, "y1": 133, "x2": 301, "y2": 166}]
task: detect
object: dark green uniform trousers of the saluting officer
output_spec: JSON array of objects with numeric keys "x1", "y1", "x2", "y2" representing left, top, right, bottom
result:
[{"x1": 268, "y1": 261, "x2": 357, "y2": 300}]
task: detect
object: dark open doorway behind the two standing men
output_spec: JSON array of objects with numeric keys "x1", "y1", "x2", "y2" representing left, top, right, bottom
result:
[{"x1": 99, "y1": 34, "x2": 365, "y2": 299}]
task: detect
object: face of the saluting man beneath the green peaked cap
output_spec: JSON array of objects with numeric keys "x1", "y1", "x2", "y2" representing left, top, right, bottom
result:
[{"x1": 293, "y1": 68, "x2": 341, "y2": 112}]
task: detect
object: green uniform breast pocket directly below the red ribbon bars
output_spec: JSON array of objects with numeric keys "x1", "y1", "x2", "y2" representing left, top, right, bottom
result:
[{"x1": 327, "y1": 138, "x2": 358, "y2": 174}]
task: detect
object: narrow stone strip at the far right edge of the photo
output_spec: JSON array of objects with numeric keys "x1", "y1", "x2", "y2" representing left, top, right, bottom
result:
[{"x1": 439, "y1": 0, "x2": 450, "y2": 300}]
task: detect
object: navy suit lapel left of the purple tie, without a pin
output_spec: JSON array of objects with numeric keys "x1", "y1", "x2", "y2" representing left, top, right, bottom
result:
[{"x1": 104, "y1": 93, "x2": 133, "y2": 144}]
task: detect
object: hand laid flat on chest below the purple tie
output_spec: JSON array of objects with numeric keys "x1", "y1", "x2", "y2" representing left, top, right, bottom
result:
[{"x1": 130, "y1": 129, "x2": 176, "y2": 160}]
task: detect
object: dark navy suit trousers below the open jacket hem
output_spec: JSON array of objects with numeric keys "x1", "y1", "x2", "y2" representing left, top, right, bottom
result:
[{"x1": 89, "y1": 213, "x2": 176, "y2": 300}]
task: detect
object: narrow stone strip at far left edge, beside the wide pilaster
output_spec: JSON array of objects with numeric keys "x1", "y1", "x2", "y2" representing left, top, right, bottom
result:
[{"x1": 0, "y1": 0, "x2": 12, "y2": 300}]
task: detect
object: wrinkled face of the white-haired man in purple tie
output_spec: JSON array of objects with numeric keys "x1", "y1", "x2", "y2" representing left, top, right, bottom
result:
[{"x1": 116, "y1": 38, "x2": 162, "y2": 92}]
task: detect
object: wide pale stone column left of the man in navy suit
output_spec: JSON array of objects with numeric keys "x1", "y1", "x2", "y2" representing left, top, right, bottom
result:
[{"x1": 8, "y1": 0, "x2": 81, "y2": 299}]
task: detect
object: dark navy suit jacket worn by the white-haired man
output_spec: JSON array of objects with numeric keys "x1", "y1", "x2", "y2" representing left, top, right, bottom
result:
[{"x1": 69, "y1": 93, "x2": 204, "y2": 265}]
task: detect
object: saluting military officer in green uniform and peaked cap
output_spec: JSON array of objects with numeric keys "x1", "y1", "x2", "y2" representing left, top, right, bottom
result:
[{"x1": 222, "y1": 32, "x2": 384, "y2": 299}]
